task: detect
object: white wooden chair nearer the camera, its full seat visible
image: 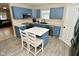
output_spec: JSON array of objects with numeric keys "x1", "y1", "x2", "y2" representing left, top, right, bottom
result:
[{"x1": 27, "y1": 32, "x2": 44, "y2": 56}]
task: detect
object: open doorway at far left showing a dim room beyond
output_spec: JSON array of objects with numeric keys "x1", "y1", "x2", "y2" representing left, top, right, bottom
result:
[{"x1": 0, "y1": 3, "x2": 13, "y2": 41}]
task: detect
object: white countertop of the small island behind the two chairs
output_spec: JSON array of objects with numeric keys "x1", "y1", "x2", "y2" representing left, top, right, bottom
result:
[{"x1": 24, "y1": 27, "x2": 49, "y2": 36}]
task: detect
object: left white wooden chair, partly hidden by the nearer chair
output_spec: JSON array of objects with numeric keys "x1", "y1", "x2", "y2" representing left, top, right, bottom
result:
[{"x1": 19, "y1": 29, "x2": 29, "y2": 53}]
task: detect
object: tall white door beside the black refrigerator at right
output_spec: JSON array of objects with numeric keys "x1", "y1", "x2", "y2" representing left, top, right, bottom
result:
[{"x1": 60, "y1": 5, "x2": 78, "y2": 46}]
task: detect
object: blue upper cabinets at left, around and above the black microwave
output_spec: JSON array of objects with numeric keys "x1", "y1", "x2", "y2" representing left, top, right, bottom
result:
[{"x1": 12, "y1": 6, "x2": 32, "y2": 19}]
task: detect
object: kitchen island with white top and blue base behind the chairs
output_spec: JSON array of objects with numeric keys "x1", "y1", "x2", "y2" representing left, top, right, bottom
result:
[{"x1": 24, "y1": 27, "x2": 49, "y2": 46}]
